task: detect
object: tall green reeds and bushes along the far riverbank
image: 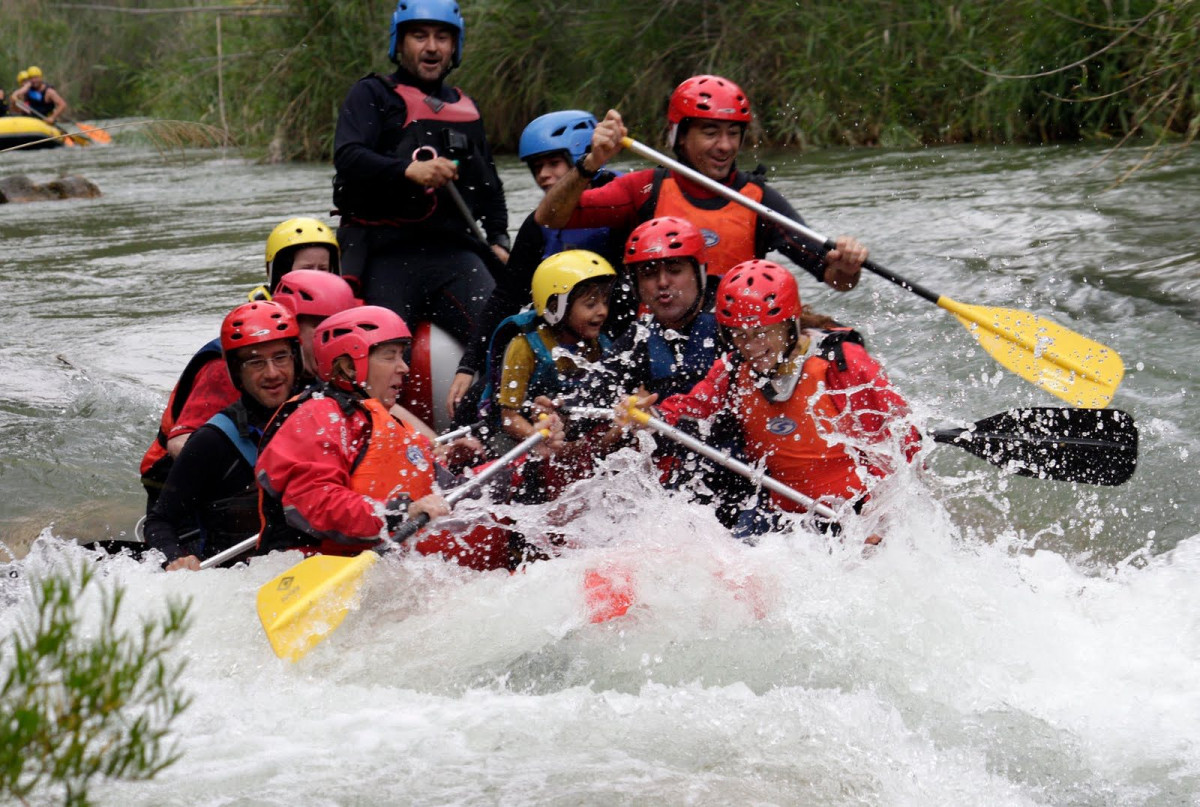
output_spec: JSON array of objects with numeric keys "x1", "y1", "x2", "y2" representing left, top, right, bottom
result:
[{"x1": 0, "y1": 0, "x2": 1200, "y2": 160}]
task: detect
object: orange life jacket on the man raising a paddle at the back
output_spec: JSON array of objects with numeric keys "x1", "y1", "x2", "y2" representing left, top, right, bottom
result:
[{"x1": 654, "y1": 170, "x2": 762, "y2": 276}]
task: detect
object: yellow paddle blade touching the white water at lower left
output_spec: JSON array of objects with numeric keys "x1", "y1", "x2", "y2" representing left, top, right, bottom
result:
[{"x1": 258, "y1": 551, "x2": 379, "y2": 662}]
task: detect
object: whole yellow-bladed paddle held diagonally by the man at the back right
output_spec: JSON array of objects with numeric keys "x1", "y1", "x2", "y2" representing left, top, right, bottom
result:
[{"x1": 622, "y1": 137, "x2": 1124, "y2": 408}]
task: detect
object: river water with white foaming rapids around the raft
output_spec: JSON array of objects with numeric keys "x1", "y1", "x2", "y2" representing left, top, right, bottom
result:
[{"x1": 0, "y1": 137, "x2": 1200, "y2": 806}]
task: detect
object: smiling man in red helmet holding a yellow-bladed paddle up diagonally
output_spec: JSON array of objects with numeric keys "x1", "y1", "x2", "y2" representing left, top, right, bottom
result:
[{"x1": 536, "y1": 76, "x2": 866, "y2": 291}]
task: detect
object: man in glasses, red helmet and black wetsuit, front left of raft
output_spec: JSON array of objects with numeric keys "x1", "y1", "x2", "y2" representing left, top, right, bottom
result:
[{"x1": 145, "y1": 301, "x2": 300, "y2": 570}]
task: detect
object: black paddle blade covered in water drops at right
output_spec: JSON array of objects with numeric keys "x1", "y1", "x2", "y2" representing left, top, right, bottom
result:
[{"x1": 934, "y1": 406, "x2": 1138, "y2": 485}]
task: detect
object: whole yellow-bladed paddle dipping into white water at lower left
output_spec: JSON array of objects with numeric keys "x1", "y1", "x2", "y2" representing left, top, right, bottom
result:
[{"x1": 258, "y1": 429, "x2": 550, "y2": 662}]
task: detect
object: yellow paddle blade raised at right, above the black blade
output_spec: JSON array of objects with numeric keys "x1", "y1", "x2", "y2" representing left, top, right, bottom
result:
[{"x1": 937, "y1": 297, "x2": 1124, "y2": 410}]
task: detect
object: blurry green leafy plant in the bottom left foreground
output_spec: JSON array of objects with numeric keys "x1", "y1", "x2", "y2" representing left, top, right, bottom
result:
[{"x1": 0, "y1": 568, "x2": 191, "y2": 805}]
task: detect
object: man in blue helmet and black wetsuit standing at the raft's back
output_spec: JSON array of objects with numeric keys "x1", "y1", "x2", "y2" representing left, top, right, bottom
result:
[{"x1": 334, "y1": 0, "x2": 509, "y2": 350}]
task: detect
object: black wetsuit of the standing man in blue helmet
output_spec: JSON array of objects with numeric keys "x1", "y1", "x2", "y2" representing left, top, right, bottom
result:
[{"x1": 334, "y1": 70, "x2": 509, "y2": 342}]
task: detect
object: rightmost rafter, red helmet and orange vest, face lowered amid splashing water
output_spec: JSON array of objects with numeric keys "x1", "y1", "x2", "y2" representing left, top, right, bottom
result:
[{"x1": 628, "y1": 261, "x2": 920, "y2": 531}]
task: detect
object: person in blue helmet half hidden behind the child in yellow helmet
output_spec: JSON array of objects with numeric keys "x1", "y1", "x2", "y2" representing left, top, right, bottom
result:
[{"x1": 446, "y1": 109, "x2": 636, "y2": 424}]
